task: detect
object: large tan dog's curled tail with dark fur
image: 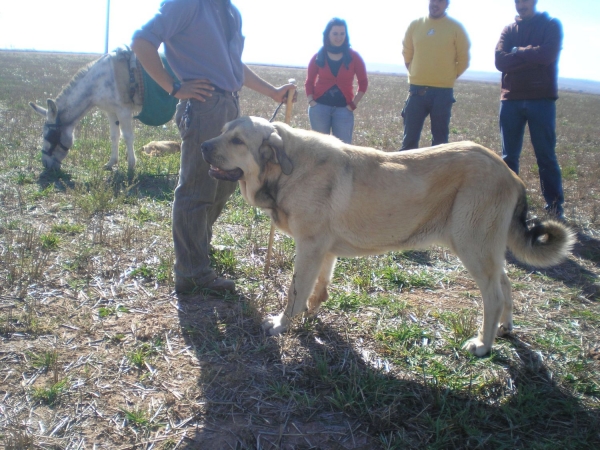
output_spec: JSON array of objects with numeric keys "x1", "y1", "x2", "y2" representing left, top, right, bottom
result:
[{"x1": 508, "y1": 189, "x2": 575, "y2": 268}]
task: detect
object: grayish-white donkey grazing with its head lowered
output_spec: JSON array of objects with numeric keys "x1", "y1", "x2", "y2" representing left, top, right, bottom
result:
[{"x1": 29, "y1": 49, "x2": 143, "y2": 171}]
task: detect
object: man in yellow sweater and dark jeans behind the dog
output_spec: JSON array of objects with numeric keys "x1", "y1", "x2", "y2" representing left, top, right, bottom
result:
[{"x1": 401, "y1": 0, "x2": 471, "y2": 150}]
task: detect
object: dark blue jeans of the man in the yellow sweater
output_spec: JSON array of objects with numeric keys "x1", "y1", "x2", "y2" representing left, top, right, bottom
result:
[{"x1": 400, "y1": 84, "x2": 456, "y2": 150}]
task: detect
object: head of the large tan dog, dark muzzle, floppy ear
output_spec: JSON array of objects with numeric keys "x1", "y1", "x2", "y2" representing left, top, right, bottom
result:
[{"x1": 201, "y1": 117, "x2": 294, "y2": 181}]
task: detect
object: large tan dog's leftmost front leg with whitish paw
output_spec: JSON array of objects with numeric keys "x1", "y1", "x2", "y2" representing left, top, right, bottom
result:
[{"x1": 263, "y1": 243, "x2": 326, "y2": 336}]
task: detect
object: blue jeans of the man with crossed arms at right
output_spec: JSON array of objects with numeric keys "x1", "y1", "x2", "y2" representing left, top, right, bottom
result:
[{"x1": 500, "y1": 99, "x2": 564, "y2": 216}]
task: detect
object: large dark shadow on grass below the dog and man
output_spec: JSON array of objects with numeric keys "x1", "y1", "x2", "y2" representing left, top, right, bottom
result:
[{"x1": 179, "y1": 290, "x2": 600, "y2": 450}]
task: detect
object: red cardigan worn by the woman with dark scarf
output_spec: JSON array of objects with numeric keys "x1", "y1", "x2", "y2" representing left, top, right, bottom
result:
[{"x1": 304, "y1": 49, "x2": 369, "y2": 104}]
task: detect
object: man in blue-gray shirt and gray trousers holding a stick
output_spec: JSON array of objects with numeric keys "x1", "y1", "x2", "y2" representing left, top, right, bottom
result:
[{"x1": 131, "y1": 0, "x2": 293, "y2": 293}]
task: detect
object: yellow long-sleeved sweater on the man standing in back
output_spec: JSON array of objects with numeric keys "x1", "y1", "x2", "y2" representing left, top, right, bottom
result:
[{"x1": 402, "y1": 16, "x2": 471, "y2": 88}]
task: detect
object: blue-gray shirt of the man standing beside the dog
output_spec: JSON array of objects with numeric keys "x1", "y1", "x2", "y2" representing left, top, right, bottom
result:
[{"x1": 133, "y1": 0, "x2": 244, "y2": 91}]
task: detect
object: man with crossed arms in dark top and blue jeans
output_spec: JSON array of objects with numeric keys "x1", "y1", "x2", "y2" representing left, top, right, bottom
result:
[{"x1": 496, "y1": 0, "x2": 564, "y2": 220}]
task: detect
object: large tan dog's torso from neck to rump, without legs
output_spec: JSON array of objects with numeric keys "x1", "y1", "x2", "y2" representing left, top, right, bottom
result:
[{"x1": 258, "y1": 123, "x2": 524, "y2": 256}]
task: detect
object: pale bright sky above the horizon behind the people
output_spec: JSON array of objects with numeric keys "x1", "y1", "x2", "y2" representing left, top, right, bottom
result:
[{"x1": 0, "y1": 0, "x2": 600, "y2": 81}]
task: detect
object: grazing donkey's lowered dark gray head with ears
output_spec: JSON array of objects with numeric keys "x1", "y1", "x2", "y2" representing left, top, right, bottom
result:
[{"x1": 29, "y1": 99, "x2": 73, "y2": 170}]
